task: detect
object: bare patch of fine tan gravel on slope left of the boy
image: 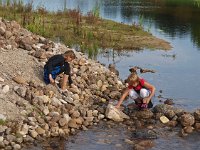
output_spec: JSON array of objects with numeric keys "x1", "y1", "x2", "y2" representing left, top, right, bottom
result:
[{"x1": 0, "y1": 48, "x2": 43, "y2": 119}]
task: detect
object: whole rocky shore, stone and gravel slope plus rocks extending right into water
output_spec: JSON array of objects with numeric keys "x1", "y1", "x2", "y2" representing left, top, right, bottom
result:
[{"x1": 0, "y1": 18, "x2": 200, "y2": 150}]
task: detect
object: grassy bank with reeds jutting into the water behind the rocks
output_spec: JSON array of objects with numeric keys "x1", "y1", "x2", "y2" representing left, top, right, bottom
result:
[{"x1": 0, "y1": 0, "x2": 171, "y2": 56}]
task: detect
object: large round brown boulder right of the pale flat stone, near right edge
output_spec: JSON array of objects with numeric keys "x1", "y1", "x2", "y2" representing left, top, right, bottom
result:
[{"x1": 180, "y1": 114, "x2": 195, "y2": 127}]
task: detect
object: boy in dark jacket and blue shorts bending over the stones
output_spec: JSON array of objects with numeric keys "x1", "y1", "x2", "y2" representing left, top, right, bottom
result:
[{"x1": 44, "y1": 50, "x2": 76, "y2": 90}]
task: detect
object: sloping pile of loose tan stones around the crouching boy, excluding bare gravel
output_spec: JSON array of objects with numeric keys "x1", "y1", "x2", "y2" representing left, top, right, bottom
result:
[{"x1": 0, "y1": 19, "x2": 123, "y2": 149}]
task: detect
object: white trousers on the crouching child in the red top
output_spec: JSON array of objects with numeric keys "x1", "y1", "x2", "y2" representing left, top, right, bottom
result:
[{"x1": 129, "y1": 88, "x2": 150, "y2": 99}]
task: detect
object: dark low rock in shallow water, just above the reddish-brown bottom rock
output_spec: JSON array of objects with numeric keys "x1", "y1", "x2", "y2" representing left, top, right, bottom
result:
[{"x1": 132, "y1": 129, "x2": 158, "y2": 139}]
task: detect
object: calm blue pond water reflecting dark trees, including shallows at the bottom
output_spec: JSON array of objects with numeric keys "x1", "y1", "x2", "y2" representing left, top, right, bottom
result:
[{"x1": 16, "y1": 0, "x2": 200, "y2": 150}]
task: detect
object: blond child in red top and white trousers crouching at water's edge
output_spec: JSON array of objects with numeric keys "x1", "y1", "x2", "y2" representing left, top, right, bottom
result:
[{"x1": 116, "y1": 72, "x2": 156, "y2": 108}]
